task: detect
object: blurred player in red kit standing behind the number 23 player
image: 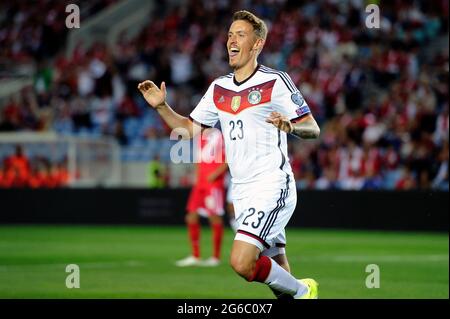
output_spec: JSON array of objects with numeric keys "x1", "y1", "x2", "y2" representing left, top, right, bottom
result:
[{"x1": 176, "y1": 129, "x2": 228, "y2": 267}]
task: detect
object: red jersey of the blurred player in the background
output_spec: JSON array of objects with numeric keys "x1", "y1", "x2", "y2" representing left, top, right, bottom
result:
[{"x1": 196, "y1": 129, "x2": 225, "y2": 187}]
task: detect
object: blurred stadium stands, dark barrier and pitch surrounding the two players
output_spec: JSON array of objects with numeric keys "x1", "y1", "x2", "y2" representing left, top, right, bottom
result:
[{"x1": 0, "y1": 0, "x2": 449, "y2": 298}]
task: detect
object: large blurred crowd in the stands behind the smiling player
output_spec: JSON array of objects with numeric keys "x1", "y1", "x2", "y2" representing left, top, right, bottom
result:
[{"x1": 0, "y1": 0, "x2": 449, "y2": 190}]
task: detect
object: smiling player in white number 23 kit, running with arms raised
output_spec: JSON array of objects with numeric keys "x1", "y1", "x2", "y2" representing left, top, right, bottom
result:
[{"x1": 138, "y1": 11, "x2": 320, "y2": 299}]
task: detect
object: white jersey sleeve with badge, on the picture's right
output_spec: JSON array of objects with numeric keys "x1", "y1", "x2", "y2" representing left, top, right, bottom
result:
[{"x1": 272, "y1": 72, "x2": 311, "y2": 122}]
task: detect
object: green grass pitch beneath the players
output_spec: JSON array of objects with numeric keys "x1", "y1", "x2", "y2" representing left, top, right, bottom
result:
[{"x1": 0, "y1": 226, "x2": 449, "y2": 299}]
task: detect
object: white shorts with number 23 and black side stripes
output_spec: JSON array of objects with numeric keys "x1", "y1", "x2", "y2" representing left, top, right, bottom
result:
[{"x1": 233, "y1": 183, "x2": 297, "y2": 257}]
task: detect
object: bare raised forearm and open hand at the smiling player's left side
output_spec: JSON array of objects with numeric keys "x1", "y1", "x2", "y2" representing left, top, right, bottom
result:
[{"x1": 138, "y1": 80, "x2": 201, "y2": 139}]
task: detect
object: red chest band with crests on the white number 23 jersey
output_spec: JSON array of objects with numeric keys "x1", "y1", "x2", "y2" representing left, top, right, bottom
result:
[{"x1": 214, "y1": 80, "x2": 276, "y2": 115}]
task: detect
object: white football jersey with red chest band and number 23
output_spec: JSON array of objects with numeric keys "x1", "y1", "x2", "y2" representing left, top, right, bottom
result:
[{"x1": 190, "y1": 65, "x2": 310, "y2": 199}]
